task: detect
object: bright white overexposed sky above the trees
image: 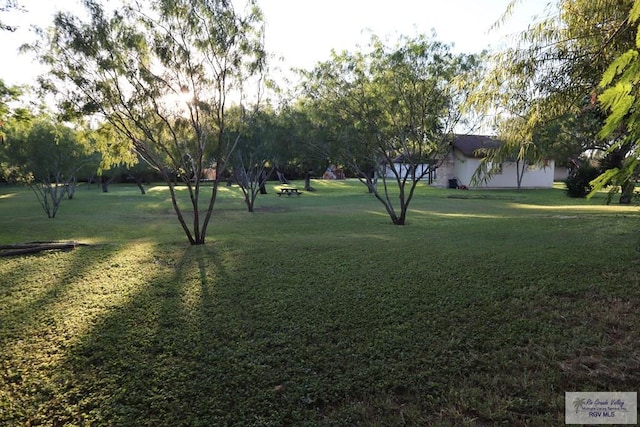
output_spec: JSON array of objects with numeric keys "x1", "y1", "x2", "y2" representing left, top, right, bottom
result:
[{"x1": 0, "y1": 0, "x2": 550, "y2": 88}]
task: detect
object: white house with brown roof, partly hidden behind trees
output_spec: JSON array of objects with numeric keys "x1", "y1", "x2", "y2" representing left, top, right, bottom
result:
[{"x1": 434, "y1": 135, "x2": 554, "y2": 188}]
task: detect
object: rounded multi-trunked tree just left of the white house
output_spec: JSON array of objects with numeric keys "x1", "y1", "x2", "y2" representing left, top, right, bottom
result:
[{"x1": 304, "y1": 36, "x2": 481, "y2": 225}]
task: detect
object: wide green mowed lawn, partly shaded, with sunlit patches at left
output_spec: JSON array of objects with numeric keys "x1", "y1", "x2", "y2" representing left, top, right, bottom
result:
[{"x1": 0, "y1": 181, "x2": 640, "y2": 426}]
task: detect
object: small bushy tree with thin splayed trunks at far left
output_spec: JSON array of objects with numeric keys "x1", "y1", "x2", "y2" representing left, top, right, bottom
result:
[{"x1": 3, "y1": 116, "x2": 97, "y2": 218}]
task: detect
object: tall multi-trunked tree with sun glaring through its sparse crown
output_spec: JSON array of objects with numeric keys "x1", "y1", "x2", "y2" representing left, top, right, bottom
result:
[{"x1": 34, "y1": 0, "x2": 265, "y2": 245}]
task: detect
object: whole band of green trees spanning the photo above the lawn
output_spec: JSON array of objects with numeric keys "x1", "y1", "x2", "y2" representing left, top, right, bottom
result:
[{"x1": 0, "y1": 0, "x2": 640, "y2": 244}]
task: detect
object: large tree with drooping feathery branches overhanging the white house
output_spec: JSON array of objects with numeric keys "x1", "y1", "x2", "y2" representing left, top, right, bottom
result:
[{"x1": 475, "y1": 0, "x2": 633, "y2": 194}]
